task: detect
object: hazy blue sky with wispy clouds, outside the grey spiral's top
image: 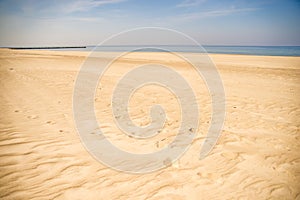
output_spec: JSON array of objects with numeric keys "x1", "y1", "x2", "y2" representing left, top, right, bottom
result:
[{"x1": 0, "y1": 0, "x2": 300, "y2": 47}]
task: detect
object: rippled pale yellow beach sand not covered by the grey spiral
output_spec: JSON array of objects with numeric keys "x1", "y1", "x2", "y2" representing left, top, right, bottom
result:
[{"x1": 0, "y1": 49, "x2": 300, "y2": 199}]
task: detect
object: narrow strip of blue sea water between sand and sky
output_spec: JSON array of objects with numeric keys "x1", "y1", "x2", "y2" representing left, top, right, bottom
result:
[{"x1": 54, "y1": 45, "x2": 300, "y2": 56}]
